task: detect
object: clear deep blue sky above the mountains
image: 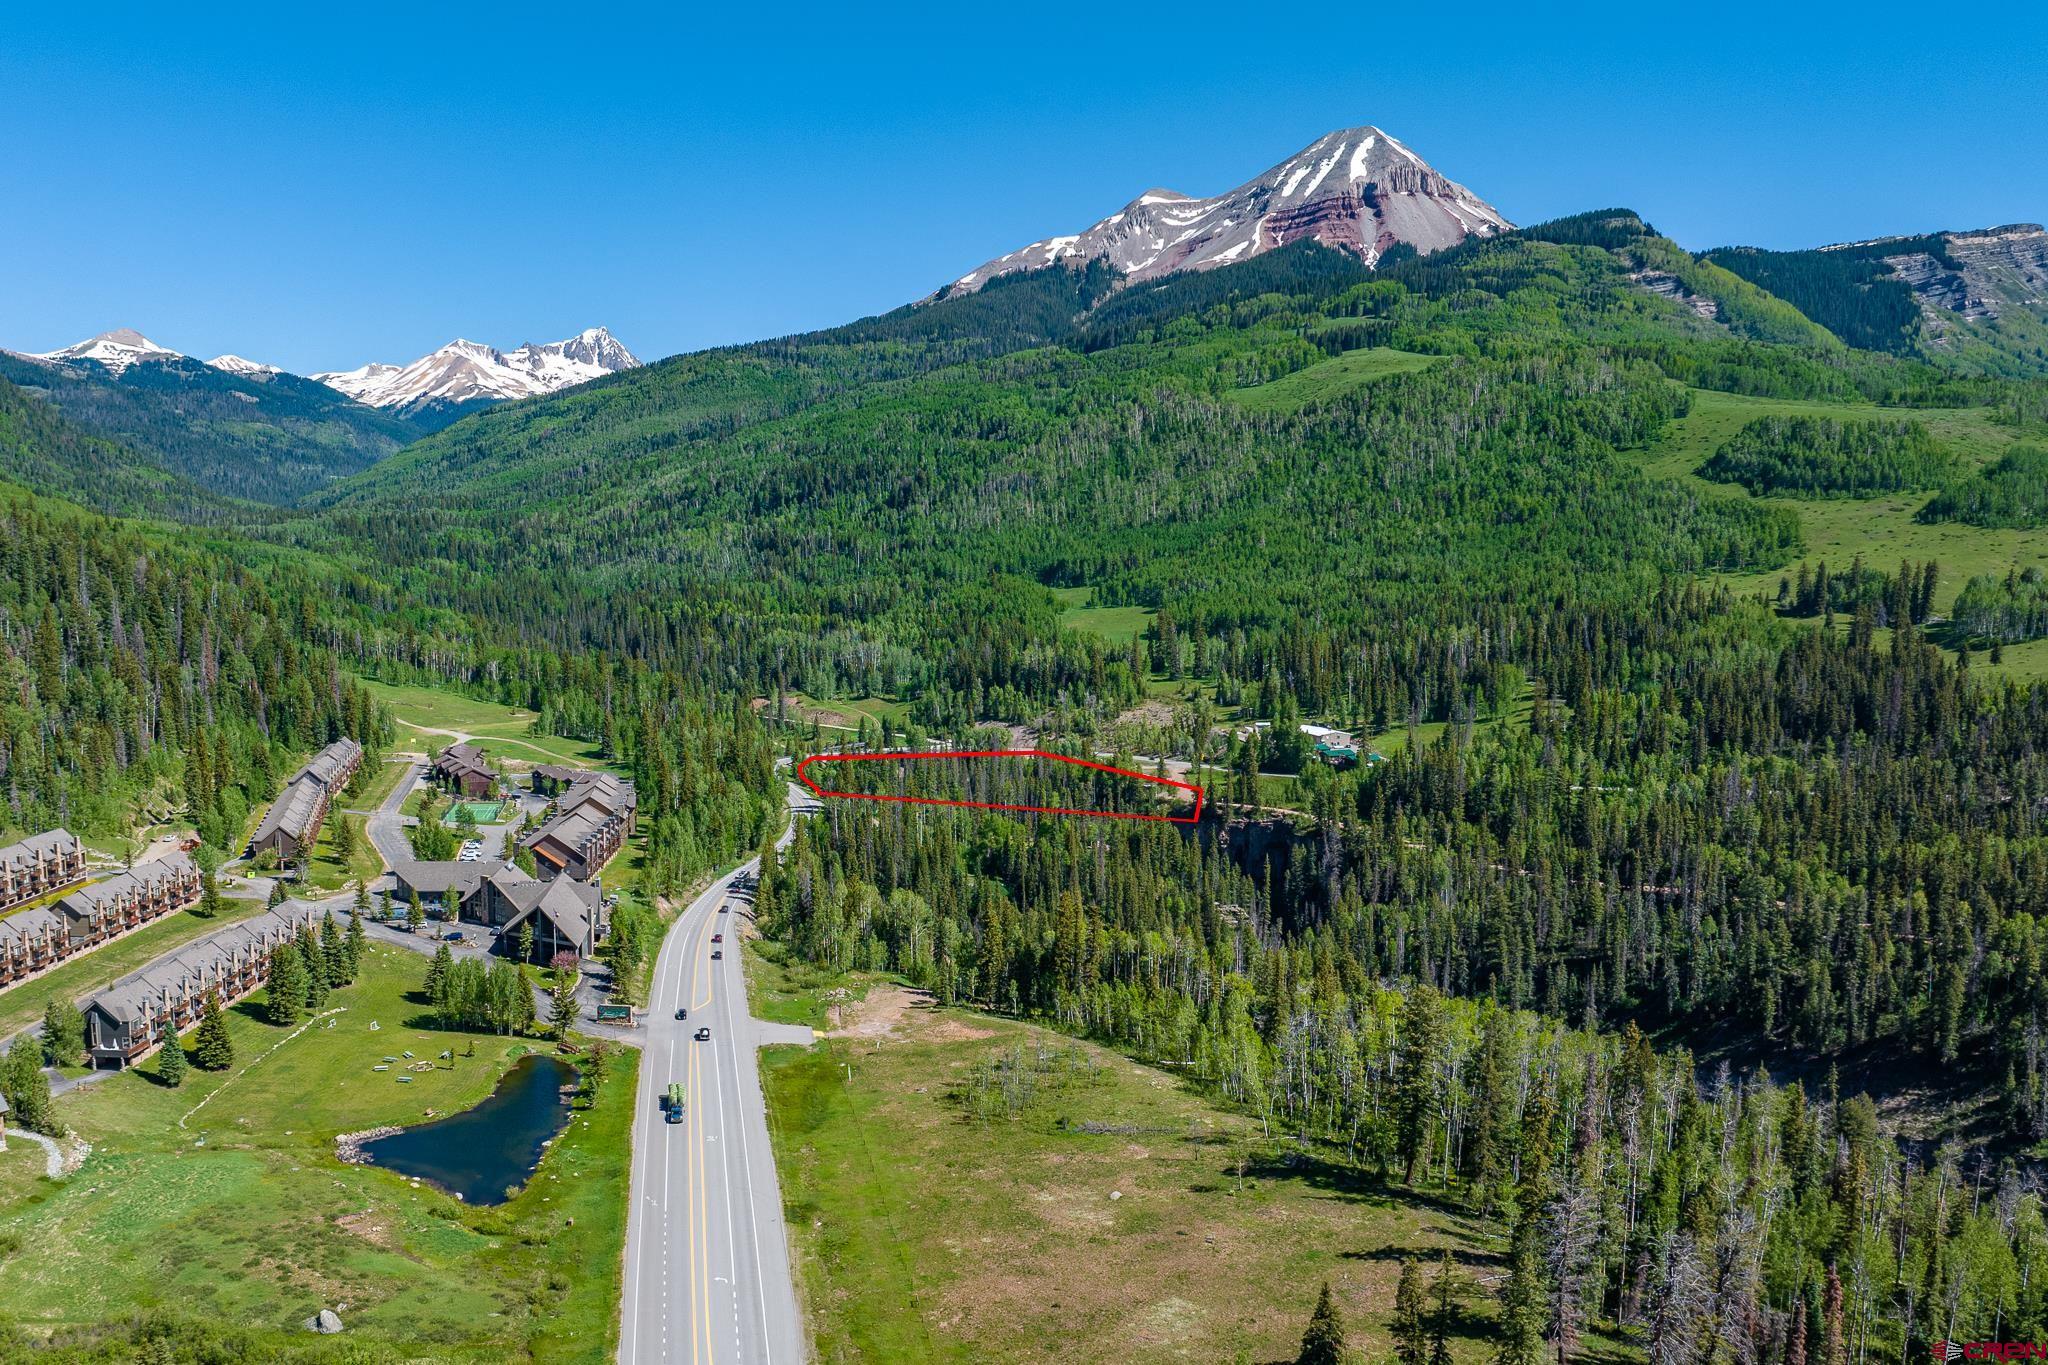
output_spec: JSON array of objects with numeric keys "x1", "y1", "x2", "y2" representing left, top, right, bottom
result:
[{"x1": 0, "y1": 2, "x2": 2048, "y2": 372}]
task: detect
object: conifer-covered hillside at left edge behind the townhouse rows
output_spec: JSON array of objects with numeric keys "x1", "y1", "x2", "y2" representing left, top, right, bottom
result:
[{"x1": 0, "y1": 495, "x2": 389, "y2": 849}]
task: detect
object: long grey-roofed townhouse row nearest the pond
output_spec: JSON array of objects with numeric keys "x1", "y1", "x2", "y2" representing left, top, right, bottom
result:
[{"x1": 86, "y1": 900, "x2": 322, "y2": 1070}]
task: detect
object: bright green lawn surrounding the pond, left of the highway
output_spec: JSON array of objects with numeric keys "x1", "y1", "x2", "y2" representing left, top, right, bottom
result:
[{"x1": 0, "y1": 945, "x2": 637, "y2": 1363}]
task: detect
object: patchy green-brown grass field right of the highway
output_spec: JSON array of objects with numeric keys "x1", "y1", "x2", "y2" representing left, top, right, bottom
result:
[{"x1": 752, "y1": 961, "x2": 1499, "y2": 1365}]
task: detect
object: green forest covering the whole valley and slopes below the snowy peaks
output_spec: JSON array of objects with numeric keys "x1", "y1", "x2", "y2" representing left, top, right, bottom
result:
[{"x1": 0, "y1": 192, "x2": 2048, "y2": 1365}]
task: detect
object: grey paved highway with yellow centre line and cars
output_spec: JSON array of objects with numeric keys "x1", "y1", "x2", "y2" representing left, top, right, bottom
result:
[{"x1": 618, "y1": 790, "x2": 811, "y2": 1365}]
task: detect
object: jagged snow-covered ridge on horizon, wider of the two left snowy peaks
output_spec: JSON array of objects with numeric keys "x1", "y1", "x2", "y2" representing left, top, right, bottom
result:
[{"x1": 313, "y1": 327, "x2": 639, "y2": 426}]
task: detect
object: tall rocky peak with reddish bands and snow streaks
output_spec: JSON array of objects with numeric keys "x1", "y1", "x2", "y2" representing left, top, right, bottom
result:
[{"x1": 942, "y1": 125, "x2": 1513, "y2": 295}]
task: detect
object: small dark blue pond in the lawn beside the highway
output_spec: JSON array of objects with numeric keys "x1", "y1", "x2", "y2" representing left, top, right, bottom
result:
[{"x1": 362, "y1": 1054, "x2": 575, "y2": 1203}]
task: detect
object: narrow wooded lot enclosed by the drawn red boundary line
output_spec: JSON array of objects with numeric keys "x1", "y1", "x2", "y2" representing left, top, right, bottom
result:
[{"x1": 797, "y1": 749, "x2": 1202, "y2": 825}]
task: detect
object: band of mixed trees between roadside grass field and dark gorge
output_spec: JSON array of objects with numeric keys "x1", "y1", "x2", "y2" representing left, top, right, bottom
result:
[{"x1": 760, "y1": 785, "x2": 2048, "y2": 1365}]
